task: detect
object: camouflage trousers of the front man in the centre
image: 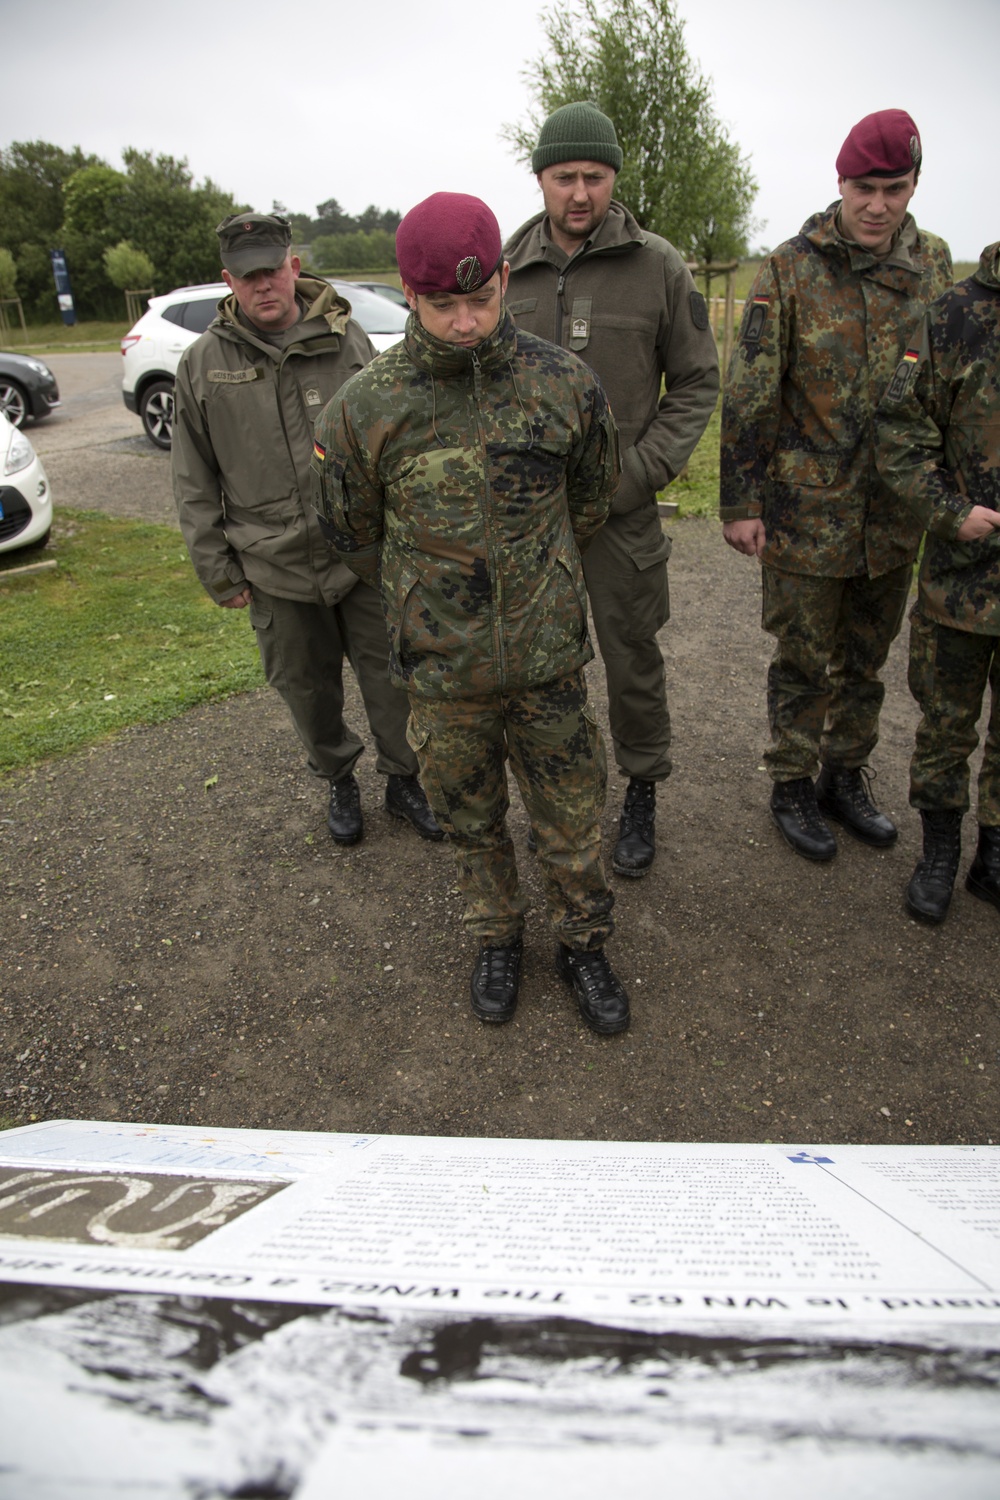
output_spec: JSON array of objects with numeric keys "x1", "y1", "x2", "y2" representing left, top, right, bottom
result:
[{"x1": 408, "y1": 672, "x2": 615, "y2": 950}]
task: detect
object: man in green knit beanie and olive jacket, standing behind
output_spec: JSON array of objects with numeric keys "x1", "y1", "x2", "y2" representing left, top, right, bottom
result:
[{"x1": 504, "y1": 104, "x2": 718, "y2": 879}]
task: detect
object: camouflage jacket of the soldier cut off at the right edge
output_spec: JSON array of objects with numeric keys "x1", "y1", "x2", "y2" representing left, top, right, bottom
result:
[{"x1": 879, "y1": 242, "x2": 1000, "y2": 636}]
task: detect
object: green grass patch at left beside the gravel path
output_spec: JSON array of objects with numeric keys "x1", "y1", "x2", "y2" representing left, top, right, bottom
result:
[{"x1": 0, "y1": 510, "x2": 262, "y2": 771}]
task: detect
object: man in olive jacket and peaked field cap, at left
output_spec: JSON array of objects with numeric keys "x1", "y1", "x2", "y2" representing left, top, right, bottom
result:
[{"x1": 171, "y1": 213, "x2": 442, "y2": 845}]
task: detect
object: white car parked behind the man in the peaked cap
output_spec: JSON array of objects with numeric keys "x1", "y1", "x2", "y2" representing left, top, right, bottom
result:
[{"x1": 121, "y1": 278, "x2": 406, "y2": 449}]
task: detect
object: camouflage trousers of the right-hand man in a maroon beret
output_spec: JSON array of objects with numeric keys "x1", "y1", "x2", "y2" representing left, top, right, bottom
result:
[{"x1": 762, "y1": 564, "x2": 913, "y2": 782}]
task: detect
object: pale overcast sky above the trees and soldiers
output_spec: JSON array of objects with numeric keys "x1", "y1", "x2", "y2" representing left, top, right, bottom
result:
[{"x1": 0, "y1": 0, "x2": 1000, "y2": 260}]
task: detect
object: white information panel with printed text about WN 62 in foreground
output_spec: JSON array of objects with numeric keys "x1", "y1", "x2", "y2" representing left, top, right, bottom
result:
[{"x1": 0, "y1": 1121, "x2": 1000, "y2": 1500}]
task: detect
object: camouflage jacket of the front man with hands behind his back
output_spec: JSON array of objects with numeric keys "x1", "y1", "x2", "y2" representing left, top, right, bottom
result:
[{"x1": 313, "y1": 312, "x2": 619, "y2": 698}]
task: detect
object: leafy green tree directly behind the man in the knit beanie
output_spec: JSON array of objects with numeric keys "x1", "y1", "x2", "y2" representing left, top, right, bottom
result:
[{"x1": 502, "y1": 0, "x2": 757, "y2": 273}]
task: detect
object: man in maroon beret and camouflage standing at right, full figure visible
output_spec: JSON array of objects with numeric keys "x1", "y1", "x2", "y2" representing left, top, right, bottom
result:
[{"x1": 721, "y1": 110, "x2": 952, "y2": 860}]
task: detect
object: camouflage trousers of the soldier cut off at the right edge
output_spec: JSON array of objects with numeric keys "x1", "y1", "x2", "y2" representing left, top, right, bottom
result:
[{"x1": 909, "y1": 603, "x2": 1000, "y2": 828}]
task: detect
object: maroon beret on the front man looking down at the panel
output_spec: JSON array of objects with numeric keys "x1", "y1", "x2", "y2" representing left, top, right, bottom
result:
[{"x1": 396, "y1": 192, "x2": 504, "y2": 296}]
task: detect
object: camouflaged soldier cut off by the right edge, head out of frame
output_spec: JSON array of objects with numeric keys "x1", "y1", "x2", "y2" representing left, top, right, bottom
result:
[{"x1": 879, "y1": 243, "x2": 1000, "y2": 923}]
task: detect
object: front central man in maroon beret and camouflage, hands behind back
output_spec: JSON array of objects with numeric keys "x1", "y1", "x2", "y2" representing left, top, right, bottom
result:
[{"x1": 315, "y1": 194, "x2": 628, "y2": 1034}]
